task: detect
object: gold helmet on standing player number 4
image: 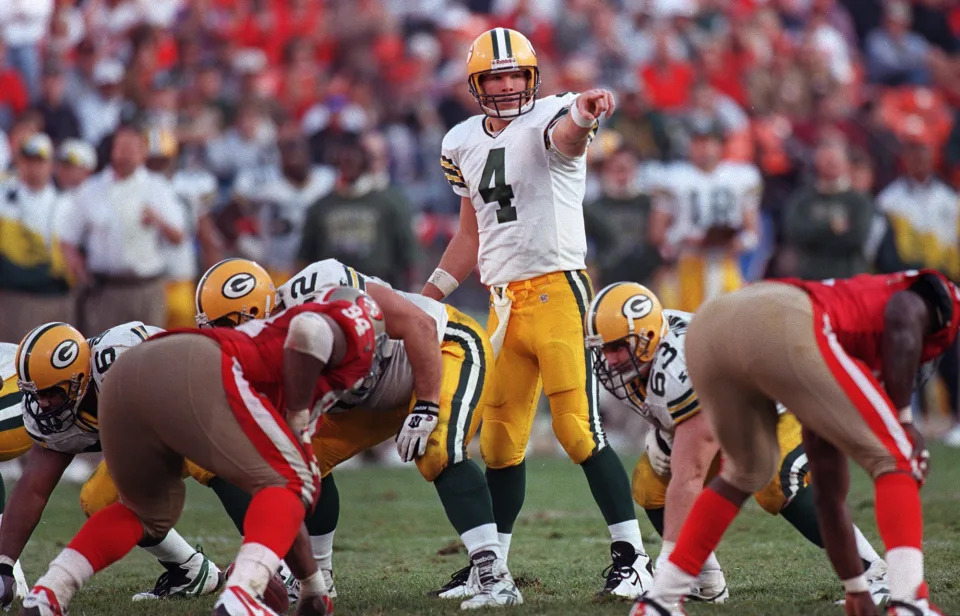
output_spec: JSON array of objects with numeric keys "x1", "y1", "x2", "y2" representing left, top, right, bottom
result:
[{"x1": 467, "y1": 28, "x2": 540, "y2": 118}]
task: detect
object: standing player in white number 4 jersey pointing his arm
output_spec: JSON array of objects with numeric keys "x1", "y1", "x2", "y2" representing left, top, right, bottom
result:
[{"x1": 422, "y1": 28, "x2": 651, "y2": 598}]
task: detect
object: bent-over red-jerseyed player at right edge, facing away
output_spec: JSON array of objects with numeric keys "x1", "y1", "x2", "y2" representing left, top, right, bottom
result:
[{"x1": 632, "y1": 270, "x2": 960, "y2": 616}]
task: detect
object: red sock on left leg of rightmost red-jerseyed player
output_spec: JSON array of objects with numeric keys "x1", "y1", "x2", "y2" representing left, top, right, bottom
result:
[{"x1": 670, "y1": 487, "x2": 740, "y2": 576}]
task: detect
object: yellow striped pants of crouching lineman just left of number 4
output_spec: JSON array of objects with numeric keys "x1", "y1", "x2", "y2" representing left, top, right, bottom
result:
[{"x1": 313, "y1": 306, "x2": 493, "y2": 481}]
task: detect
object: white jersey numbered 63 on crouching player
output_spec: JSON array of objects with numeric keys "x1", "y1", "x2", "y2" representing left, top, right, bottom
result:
[{"x1": 626, "y1": 310, "x2": 700, "y2": 434}]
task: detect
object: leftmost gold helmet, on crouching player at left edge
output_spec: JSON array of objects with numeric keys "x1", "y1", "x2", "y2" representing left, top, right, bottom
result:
[{"x1": 16, "y1": 322, "x2": 96, "y2": 434}]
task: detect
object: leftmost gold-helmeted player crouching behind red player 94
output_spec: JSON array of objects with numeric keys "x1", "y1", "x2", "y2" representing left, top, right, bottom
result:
[{"x1": 0, "y1": 322, "x2": 223, "y2": 606}]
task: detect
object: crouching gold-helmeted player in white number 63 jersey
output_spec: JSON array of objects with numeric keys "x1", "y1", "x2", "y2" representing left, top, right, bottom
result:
[{"x1": 584, "y1": 282, "x2": 889, "y2": 605}]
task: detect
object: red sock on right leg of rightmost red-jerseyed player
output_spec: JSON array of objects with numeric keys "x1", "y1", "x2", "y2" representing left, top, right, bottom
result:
[{"x1": 873, "y1": 473, "x2": 923, "y2": 550}]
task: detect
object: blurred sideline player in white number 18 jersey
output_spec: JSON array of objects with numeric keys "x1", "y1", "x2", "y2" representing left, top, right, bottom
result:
[{"x1": 648, "y1": 122, "x2": 763, "y2": 312}]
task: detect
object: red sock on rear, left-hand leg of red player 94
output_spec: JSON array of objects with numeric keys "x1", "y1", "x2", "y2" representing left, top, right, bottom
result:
[{"x1": 67, "y1": 503, "x2": 143, "y2": 571}]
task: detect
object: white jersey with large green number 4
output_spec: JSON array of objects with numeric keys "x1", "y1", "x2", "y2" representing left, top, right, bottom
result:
[{"x1": 440, "y1": 93, "x2": 587, "y2": 285}]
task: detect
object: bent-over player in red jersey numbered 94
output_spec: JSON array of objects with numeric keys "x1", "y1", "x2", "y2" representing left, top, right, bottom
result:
[{"x1": 21, "y1": 286, "x2": 385, "y2": 616}]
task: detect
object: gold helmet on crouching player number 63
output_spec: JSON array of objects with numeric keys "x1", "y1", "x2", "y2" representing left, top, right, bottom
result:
[{"x1": 583, "y1": 282, "x2": 667, "y2": 399}]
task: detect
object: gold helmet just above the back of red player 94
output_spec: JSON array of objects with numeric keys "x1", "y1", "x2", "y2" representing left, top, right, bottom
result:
[{"x1": 196, "y1": 259, "x2": 277, "y2": 327}]
